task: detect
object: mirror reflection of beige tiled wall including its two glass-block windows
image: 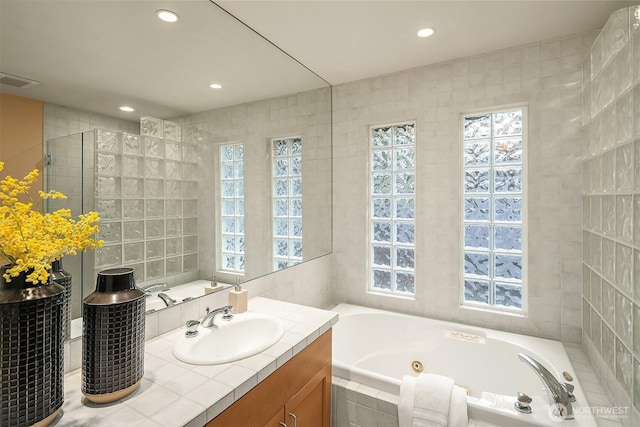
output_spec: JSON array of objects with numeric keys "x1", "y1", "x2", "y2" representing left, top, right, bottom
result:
[{"x1": 194, "y1": 88, "x2": 331, "y2": 283}]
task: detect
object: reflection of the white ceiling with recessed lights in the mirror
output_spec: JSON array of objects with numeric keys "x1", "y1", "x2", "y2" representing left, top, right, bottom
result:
[{"x1": 0, "y1": 0, "x2": 326, "y2": 120}]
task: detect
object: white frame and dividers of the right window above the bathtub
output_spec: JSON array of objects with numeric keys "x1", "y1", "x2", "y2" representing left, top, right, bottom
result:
[{"x1": 459, "y1": 104, "x2": 529, "y2": 317}]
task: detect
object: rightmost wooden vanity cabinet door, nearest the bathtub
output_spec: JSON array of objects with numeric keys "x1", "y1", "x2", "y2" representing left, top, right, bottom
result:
[{"x1": 284, "y1": 365, "x2": 331, "y2": 427}]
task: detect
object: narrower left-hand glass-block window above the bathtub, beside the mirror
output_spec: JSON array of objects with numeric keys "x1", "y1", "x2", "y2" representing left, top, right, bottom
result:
[{"x1": 369, "y1": 123, "x2": 416, "y2": 296}]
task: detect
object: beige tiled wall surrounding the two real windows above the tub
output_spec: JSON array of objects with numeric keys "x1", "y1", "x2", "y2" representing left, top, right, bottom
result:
[{"x1": 333, "y1": 32, "x2": 597, "y2": 343}]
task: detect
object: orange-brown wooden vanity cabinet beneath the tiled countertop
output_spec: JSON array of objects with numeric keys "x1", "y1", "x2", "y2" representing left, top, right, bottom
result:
[{"x1": 207, "y1": 330, "x2": 331, "y2": 427}]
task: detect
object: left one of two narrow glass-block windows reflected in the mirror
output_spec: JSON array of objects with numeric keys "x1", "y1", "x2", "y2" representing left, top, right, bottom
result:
[{"x1": 220, "y1": 144, "x2": 244, "y2": 273}]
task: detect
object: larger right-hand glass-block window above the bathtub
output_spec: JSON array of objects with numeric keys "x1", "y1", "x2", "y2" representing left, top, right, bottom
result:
[{"x1": 462, "y1": 108, "x2": 527, "y2": 312}]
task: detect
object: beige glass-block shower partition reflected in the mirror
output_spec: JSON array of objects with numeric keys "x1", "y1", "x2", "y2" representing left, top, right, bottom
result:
[{"x1": 95, "y1": 117, "x2": 198, "y2": 284}]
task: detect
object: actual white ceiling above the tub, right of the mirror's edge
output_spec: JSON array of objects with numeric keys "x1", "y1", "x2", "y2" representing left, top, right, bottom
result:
[{"x1": 216, "y1": 0, "x2": 637, "y2": 84}]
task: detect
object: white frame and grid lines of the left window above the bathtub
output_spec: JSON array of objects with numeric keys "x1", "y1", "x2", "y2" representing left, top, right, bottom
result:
[{"x1": 366, "y1": 120, "x2": 418, "y2": 300}]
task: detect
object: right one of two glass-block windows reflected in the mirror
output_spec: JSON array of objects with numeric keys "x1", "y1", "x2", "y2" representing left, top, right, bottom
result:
[{"x1": 271, "y1": 137, "x2": 302, "y2": 270}]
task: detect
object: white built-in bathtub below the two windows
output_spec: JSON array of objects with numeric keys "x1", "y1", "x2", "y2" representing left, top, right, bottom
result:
[{"x1": 333, "y1": 304, "x2": 597, "y2": 427}]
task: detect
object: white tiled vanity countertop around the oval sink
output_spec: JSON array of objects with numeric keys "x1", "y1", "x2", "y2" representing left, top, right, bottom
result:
[{"x1": 51, "y1": 297, "x2": 338, "y2": 427}]
